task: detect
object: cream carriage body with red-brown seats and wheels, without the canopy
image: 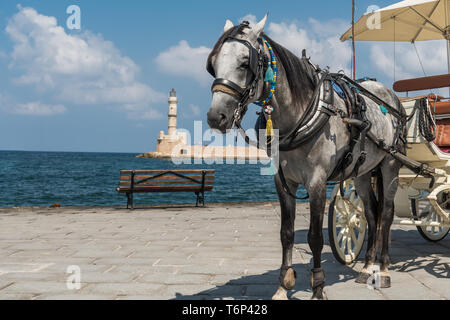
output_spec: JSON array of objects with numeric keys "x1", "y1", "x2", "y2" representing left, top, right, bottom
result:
[{"x1": 328, "y1": 75, "x2": 450, "y2": 264}]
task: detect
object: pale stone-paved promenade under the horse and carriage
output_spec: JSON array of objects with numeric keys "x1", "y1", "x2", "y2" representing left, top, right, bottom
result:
[{"x1": 0, "y1": 203, "x2": 450, "y2": 299}]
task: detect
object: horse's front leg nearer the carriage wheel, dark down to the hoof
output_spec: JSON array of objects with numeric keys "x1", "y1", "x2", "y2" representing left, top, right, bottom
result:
[{"x1": 306, "y1": 178, "x2": 327, "y2": 300}]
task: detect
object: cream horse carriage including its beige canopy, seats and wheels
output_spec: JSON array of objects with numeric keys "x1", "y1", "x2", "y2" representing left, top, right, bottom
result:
[{"x1": 328, "y1": 0, "x2": 450, "y2": 264}]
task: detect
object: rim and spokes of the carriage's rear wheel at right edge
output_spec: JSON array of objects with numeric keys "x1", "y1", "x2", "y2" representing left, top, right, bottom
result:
[{"x1": 417, "y1": 193, "x2": 449, "y2": 240}]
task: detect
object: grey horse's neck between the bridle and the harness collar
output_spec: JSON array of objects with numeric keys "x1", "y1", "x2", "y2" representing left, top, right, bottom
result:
[{"x1": 272, "y1": 56, "x2": 315, "y2": 136}]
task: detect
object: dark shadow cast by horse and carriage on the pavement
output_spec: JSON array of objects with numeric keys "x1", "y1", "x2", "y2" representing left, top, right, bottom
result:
[{"x1": 174, "y1": 228, "x2": 450, "y2": 300}]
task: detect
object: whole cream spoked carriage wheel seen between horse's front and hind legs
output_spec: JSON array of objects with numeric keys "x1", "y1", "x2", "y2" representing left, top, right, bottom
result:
[{"x1": 328, "y1": 179, "x2": 367, "y2": 264}]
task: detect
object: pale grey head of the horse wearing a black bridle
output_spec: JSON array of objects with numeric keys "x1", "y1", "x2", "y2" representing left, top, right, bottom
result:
[{"x1": 207, "y1": 14, "x2": 267, "y2": 133}]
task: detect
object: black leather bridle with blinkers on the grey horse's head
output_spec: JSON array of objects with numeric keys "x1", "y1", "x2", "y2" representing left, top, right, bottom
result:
[{"x1": 206, "y1": 21, "x2": 268, "y2": 128}]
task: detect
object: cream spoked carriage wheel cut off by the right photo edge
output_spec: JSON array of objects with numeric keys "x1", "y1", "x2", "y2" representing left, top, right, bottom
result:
[{"x1": 412, "y1": 194, "x2": 450, "y2": 242}]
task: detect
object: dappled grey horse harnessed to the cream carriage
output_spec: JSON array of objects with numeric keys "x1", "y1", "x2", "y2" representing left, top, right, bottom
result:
[{"x1": 207, "y1": 15, "x2": 404, "y2": 299}]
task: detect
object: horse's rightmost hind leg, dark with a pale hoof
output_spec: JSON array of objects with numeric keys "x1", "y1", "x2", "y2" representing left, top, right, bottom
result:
[{"x1": 379, "y1": 156, "x2": 401, "y2": 288}]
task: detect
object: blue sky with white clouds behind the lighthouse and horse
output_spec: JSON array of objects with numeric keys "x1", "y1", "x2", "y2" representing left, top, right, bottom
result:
[{"x1": 0, "y1": 0, "x2": 447, "y2": 153}]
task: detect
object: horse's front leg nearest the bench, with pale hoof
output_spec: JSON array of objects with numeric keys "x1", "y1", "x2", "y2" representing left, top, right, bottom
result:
[{"x1": 272, "y1": 175, "x2": 298, "y2": 300}]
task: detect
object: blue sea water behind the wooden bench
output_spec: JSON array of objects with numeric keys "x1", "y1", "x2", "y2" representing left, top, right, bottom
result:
[{"x1": 0, "y1": 151, "x2": 331, "y2": 207}]
